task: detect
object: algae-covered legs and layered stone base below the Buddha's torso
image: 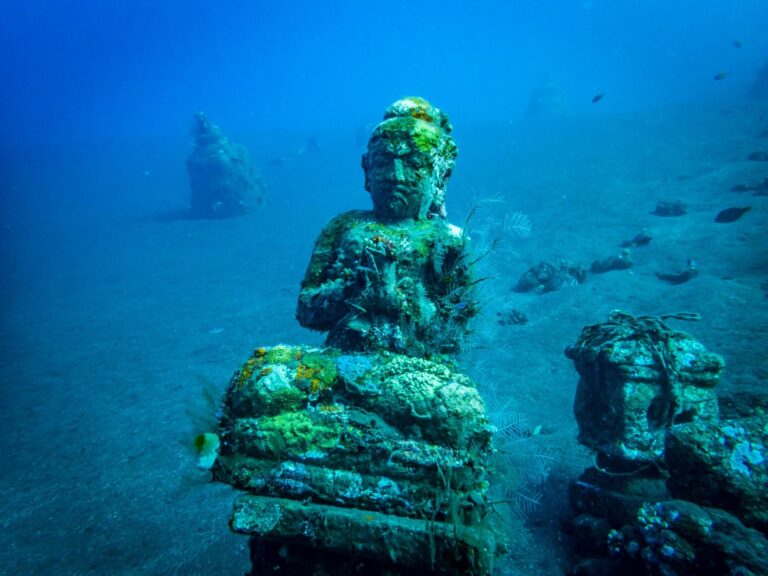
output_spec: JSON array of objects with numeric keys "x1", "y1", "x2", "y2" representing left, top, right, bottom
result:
[{"x1": 213, "y1": 346, "x2": 503, "y2": 574}]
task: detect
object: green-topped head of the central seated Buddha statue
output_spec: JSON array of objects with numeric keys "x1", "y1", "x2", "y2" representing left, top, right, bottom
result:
[{"x1": 362, "y1": 97, "x2": 458, "y2": 220}]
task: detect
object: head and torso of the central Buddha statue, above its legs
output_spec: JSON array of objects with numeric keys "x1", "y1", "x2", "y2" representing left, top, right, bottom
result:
[{"x1": 296, "y1": 98, "x2": 477, "y2": 356}]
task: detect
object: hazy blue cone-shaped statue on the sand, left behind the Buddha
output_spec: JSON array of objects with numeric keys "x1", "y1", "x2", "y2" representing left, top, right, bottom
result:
[{"x1": 187, "y1": 112, "x2": 265, "y2": 218}]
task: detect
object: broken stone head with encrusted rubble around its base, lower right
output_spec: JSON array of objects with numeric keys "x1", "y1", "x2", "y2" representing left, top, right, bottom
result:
[{"x1": 566, "y1": 311, "x2": 768, "y2": 576}]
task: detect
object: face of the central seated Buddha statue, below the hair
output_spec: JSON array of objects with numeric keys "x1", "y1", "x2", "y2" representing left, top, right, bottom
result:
[{"x1": 363, "y1": 146, "x2": 433, "y2": 219}]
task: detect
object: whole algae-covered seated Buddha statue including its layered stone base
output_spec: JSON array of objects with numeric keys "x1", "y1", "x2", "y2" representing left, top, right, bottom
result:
[{"x1": 204, "y1": 98, "x2": 504, "y2": 576}]
